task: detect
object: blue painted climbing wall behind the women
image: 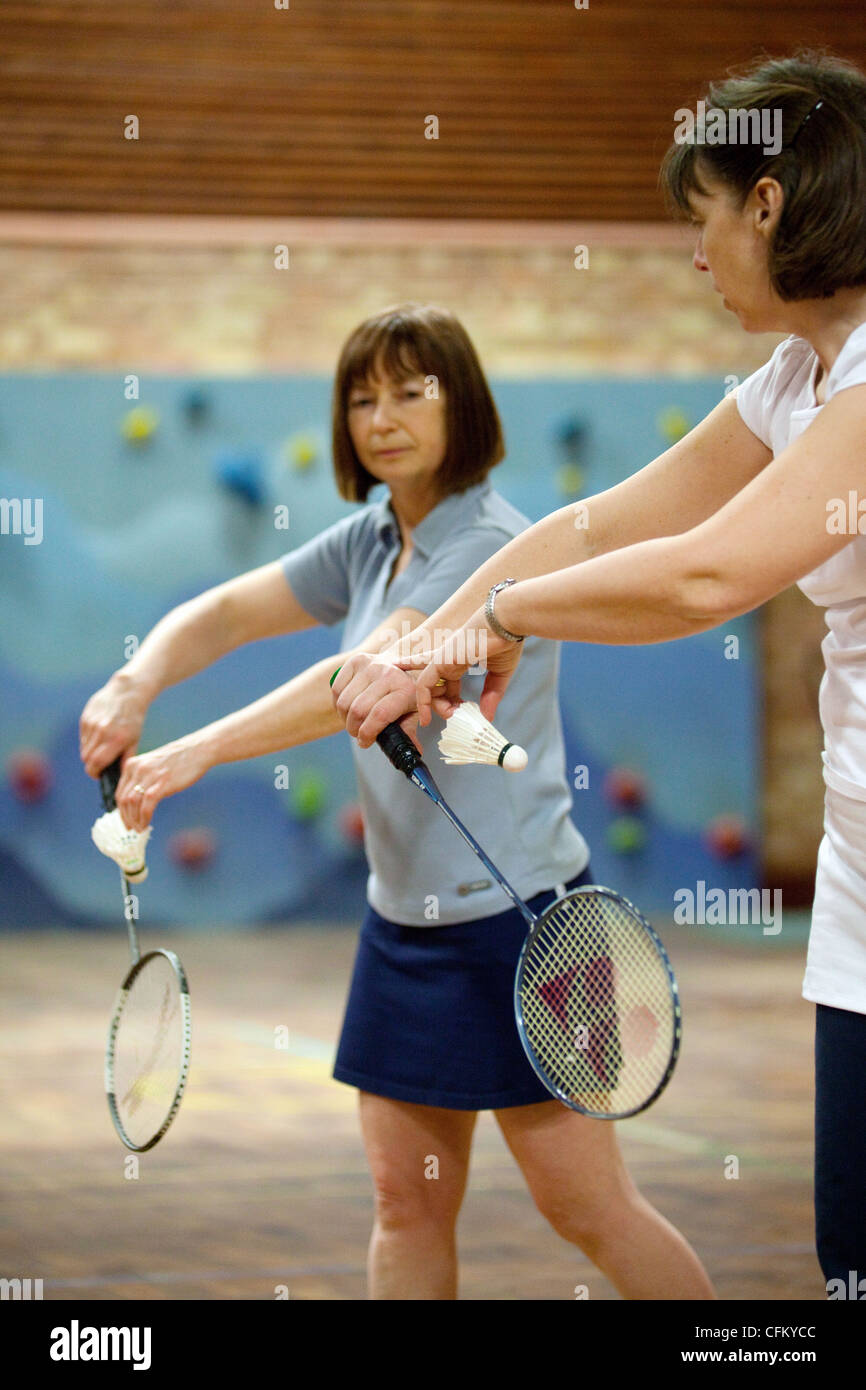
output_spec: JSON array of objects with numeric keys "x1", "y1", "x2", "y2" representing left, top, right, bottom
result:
[{"x1": 0, "y1": 375, "x2": 759, "y2": 927}]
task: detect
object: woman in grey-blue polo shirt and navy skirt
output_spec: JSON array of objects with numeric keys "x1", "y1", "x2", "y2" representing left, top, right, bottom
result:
[{"x1": 81, "y1": 304, "x2": 713, "y2": 1300}]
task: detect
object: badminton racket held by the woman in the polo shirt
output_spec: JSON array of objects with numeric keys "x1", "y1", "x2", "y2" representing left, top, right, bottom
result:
[{"x1": 99, "y1": 758, "x2": 190, "y2": 1154}]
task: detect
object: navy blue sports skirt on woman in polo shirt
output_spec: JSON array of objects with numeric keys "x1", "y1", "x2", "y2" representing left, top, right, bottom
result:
[{"x1": 334, "y1": 867, "x2": 592, "y2": 1111}]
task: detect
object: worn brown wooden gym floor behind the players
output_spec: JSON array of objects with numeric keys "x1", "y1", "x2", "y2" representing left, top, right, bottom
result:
[{"x1": 0, "y1": 926, "x2": 826, "y2": 1300}]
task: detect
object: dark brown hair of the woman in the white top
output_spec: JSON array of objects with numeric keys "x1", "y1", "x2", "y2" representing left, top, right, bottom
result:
[{"x1": 660, "y1": 50, "x2": 866, "y2": 300}]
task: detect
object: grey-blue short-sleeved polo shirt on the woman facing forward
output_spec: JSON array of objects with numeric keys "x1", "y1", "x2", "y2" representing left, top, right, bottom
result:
[{"x1": 282, "y1": 481, "x2": 589, "y2": 927}]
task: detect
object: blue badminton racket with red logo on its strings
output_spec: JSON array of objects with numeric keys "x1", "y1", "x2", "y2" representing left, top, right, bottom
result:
[{"x1": 377, "y1": 723, "x2": 683, "y2": 1120}]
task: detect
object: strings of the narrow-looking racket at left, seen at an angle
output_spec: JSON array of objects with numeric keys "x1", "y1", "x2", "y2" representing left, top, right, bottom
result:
[{"x1": 111, "y1": 955, "x2": 189, "y2": 1145}]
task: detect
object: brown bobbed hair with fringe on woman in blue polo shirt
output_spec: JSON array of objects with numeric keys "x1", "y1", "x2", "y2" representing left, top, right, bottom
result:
[{"x1": 332, "y1": 304, "x2": 505, "y2": 502}]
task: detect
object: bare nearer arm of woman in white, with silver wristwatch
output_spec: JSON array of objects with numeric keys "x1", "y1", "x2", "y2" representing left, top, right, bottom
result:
[{"x1": 408, "y1": 386, "x2": 866, "y2": 723}]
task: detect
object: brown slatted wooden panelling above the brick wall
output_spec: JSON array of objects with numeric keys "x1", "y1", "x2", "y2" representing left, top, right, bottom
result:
[{"x1": 0, "y1": 0, "x2": 866, "y2": 221}]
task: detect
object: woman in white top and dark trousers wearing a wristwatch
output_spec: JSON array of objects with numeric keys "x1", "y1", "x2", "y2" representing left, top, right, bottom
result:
[{"x1": 334, "y1": 53, "x2": 866, "y2": 1297}]
